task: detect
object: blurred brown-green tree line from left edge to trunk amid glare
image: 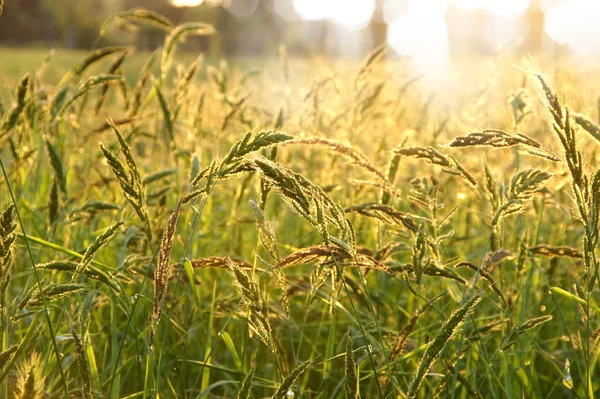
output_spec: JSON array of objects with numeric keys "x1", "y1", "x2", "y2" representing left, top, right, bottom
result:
[{"x1": 0, "y1": 0, "x2": 386, "y2": 56}]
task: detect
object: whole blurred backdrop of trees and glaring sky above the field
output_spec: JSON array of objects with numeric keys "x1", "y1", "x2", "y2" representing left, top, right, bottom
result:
[{"x1": 0, "y1": 0, "x2": 600, "y2": 64}]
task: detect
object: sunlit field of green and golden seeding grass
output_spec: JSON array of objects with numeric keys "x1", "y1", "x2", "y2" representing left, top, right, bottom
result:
[{"x1": 0, "y1": 12, "x2": 600, "y2": 399}]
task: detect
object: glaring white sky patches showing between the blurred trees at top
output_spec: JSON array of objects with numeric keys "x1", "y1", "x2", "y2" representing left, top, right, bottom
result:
[{"x1": 172, "y1": 0, "x2": 600, "y2": 61}]
